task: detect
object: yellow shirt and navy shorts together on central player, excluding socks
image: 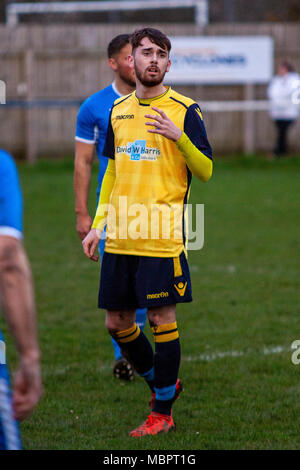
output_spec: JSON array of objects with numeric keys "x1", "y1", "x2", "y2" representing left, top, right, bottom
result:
[{"x1": 93, "y1": 88, "x2": 212, "y2": 309}]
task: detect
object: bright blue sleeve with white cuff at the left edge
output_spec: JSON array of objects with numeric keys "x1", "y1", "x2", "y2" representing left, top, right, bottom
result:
[{"x1": 0, "y1": 150, "x2": 23, "y2": 238}]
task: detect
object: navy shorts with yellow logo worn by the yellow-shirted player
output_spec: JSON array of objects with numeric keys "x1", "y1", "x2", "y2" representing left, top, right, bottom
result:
[{"x1": 98, "y1": 251, "x2": 193, "y2": 310}]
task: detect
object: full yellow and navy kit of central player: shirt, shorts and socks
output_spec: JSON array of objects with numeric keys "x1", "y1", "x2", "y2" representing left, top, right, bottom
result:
[{"x1": 93, "y1": 88, "x2": 212, "y2": 416}]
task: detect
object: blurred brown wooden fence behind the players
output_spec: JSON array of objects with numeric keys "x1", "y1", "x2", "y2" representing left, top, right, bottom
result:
[{"x1": 0, "y1": 23, "x2": 300, "y2": 161}]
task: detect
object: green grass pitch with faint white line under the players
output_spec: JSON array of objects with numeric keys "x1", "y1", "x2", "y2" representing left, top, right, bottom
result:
[{"x1": 1, "y1": 157, "x2": 300, "y2": 450}]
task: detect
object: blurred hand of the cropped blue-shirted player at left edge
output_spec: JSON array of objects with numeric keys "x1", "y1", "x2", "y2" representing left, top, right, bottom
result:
[{"x1": 13, "y1": 352, "x2": 43, "y2": 421}]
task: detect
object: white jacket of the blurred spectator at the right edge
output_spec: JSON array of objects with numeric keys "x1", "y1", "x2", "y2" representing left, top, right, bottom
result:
[{"x1": 267, "y1": 72, "x2": 300, "y2": 120}]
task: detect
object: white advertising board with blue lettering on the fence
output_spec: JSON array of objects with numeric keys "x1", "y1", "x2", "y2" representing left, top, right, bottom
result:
[{"x1": 166, "y1": 36, "x2": 273, "y2": 84}]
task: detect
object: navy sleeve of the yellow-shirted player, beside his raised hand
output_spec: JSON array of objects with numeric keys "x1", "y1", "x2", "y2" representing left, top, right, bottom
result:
[{"x1": 184, "y1": 103, "x2": 212, "y2": 160}]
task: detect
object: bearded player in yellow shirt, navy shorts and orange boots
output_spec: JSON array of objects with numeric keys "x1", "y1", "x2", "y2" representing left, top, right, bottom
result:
[{"x1": 82, "y1": 28, "x2": 212, "y2": 437}]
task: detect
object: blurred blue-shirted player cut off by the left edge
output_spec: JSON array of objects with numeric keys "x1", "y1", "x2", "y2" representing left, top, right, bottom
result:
[{"x1": 0, "y1": 149, "x2": 42, "y2": 450}]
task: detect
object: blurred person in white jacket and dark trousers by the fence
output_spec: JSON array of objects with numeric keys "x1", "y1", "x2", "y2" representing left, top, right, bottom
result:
[{"x1": 267, "y1": 62, "x2": 300, "y2": 157}]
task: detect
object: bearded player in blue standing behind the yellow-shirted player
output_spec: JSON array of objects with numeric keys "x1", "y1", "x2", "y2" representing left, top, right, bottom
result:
[{"x1": 74, "y1": 34, "x2": 146, "y2": 380}]
